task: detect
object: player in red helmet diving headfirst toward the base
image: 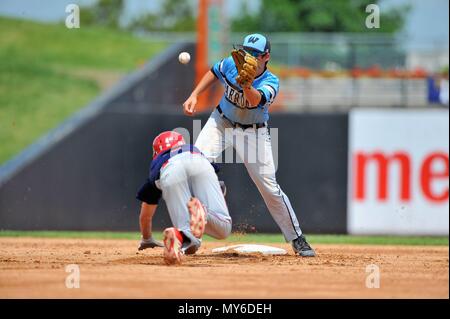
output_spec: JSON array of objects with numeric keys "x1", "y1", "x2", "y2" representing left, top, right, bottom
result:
[{"x1": 136, "y1": 131, "x2": 231, "y2": 265}]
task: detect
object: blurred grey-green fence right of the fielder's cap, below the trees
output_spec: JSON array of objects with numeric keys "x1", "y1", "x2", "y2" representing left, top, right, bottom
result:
[{"x1": 230, "y1": 33, "x2": 406, "y2": 70}]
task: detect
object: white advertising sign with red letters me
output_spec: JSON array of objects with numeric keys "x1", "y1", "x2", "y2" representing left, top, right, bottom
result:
[{"x1": 347, "y1": 110, "x2": 449, "y2": 235}]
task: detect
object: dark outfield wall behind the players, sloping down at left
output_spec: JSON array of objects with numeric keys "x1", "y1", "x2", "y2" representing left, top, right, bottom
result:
[{"x1": 0, "y1": 111, "x2": 347, "y2": 233}]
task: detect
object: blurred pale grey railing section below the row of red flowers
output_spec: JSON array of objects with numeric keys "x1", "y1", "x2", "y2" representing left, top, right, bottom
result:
[{"x1": 275, "y1": 78, "x2": 429, "y2": 112}]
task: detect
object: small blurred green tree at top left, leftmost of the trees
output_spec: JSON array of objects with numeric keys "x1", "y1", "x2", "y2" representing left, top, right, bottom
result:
[{"x1": 80, "y1": 0, "x2": 124, "y2": 29}]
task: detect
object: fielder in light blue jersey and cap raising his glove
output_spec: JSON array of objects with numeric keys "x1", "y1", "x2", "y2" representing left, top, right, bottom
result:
[{"x1": 183, "y1": 34, "x2": 315, "y2": 257}]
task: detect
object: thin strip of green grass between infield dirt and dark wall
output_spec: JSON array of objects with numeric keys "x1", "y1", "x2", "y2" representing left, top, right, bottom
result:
[{"x1": 0, "y1": 230, "x2": 448, "y2": 246}]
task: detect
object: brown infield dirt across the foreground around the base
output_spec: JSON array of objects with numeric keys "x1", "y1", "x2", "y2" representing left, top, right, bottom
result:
[{"x1": 0, "y1": 237, "x2": 449, "y2": 299}]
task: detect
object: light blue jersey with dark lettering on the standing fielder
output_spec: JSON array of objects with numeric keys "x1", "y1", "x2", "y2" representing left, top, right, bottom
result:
[{"x1": 211, "y1": 56, "x2": 279, "y2": 124}]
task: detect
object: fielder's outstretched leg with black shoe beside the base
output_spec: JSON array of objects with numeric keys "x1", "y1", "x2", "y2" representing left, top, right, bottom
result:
[{"x1": 235, "y1": 128, "x2": 314, "y2": 256}]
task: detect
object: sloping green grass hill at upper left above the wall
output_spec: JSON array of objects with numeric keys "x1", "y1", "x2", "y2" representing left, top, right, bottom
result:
[{"x1": 0, "y1": 17, "x2": 167, "y2": 164}]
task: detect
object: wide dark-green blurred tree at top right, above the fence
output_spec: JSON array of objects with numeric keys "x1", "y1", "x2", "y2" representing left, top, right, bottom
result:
[{"x1": 231, "y1": 0, "x2": 410, "y2": 33}]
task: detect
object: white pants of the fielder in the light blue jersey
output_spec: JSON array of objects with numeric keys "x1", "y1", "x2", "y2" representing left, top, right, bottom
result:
[{"x1": 195, "y1": 109, "x2": 302, "y2": 241}]
